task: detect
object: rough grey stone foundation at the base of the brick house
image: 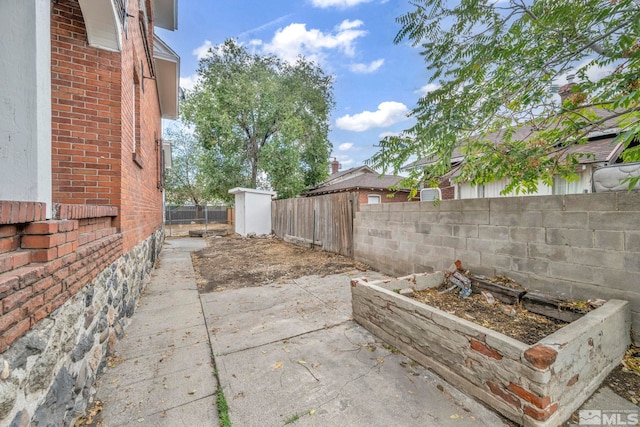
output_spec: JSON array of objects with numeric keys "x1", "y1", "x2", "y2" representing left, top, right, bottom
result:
[{"x1": 0, "y1": 229, "x2": 164, "y2": 427}]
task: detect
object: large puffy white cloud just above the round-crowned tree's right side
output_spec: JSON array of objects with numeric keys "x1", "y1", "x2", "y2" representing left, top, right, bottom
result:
[{"x1": 263, "y1": 20, "x2": 367, "y2": 62}]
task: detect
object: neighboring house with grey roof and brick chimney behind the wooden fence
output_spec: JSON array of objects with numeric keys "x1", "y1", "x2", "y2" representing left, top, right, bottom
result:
[{"x1": 302, "y1": 160, "x2": 420, "y2": 205}]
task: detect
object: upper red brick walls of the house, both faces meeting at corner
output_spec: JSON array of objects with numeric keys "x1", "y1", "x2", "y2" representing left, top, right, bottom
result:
[{"x1": 51, "y1": 0, "x2": 162, "y2": 252}]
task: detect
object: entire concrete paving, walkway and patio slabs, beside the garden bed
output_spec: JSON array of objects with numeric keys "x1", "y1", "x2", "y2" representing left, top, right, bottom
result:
[{"x1": 92, "y1": 239, "x2": 504, "y2": 427}]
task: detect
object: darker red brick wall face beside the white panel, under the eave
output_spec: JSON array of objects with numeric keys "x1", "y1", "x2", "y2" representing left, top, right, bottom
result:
[{"x1": 51, "y1": 0, "x2": 122, "y2": 211}]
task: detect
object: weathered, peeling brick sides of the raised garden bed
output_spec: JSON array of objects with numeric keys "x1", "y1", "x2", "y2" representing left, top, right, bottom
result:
[{"x1": 351, "y1": 275, "x2": 630, "y2": 426}]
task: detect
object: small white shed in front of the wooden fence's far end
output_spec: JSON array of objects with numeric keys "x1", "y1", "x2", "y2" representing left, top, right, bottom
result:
[{"x1": 229, "y1": 187, "x2": 276, "y2": 236}]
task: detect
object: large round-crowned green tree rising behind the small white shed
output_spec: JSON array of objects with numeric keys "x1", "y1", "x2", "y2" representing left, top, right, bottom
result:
[{"x1": 181, "y1": 40, "x2": 334, "y2": 197}]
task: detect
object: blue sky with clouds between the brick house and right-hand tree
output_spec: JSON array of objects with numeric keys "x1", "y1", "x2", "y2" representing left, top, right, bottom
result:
[{"x1": 157, "y1": 0, "x2": 428, "y2": 169}]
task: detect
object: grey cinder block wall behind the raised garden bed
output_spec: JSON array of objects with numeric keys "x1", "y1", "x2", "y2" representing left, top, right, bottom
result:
[{"x1": 354, "y1": 191, "x2": 640, "y2": 342}]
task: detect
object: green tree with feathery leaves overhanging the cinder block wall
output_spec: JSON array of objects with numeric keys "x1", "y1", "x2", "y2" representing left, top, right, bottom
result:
[{"x1": 370, "y1": 0, "x2": 640, "y2": 193}]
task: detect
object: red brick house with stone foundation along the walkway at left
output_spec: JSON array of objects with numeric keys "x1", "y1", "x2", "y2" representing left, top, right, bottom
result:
[{"x1": 0, "y1": 0, "x2": 179, "y2": 425}]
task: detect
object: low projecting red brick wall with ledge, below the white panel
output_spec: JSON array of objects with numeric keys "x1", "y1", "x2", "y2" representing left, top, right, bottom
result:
[{"x1": 0, "y1": 201, "x2": 122, "y2": 353}]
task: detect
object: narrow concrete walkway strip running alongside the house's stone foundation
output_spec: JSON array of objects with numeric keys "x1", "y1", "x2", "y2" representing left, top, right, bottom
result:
[{"x1": 96, "y1": 239, "x2": 218, "y2": 427}]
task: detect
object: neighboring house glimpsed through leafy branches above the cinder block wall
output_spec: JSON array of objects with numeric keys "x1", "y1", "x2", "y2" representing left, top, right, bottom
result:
[{"x1": 404, "y1": 84, "x2": 636, "y2": 200}]
